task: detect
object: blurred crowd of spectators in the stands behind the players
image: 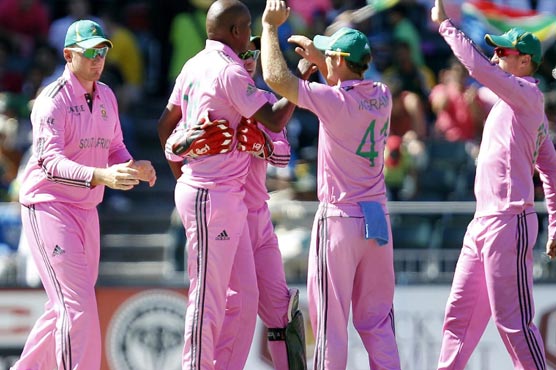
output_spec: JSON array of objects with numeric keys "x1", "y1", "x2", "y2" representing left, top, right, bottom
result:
[{"x1": 0, "y1": 0, "x2": 556, "y2": 205}]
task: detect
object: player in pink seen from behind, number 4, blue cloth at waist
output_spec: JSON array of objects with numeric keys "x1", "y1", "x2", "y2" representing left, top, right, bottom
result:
[{"x1": 261, "y1": 0, "x2": 400, "y2": 370}]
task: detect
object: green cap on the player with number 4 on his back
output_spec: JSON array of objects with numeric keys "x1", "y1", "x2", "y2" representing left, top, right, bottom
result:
[{"x1": 313, "y1": 27, "x2": 371, "y2": 64}]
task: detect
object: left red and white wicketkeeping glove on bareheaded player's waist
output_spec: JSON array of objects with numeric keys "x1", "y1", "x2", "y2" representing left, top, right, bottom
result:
[{"x1": 168, "y1": 118, "x2": 234, "y2": 158}]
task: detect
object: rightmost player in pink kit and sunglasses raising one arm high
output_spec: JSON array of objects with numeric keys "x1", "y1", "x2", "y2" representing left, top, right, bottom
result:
[{"x1": 431, "y1": 0, "x2": 556, "y2": 370}]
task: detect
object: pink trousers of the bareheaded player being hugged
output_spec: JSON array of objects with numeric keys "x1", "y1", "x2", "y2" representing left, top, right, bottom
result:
[{"x1": 175, "y1": 183, "x2": 259, "y2": 370}]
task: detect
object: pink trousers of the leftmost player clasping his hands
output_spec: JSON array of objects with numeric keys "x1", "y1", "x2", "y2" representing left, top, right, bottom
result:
[{"x1": 12, "y1": 203, "x2": 101, "y2": 370}]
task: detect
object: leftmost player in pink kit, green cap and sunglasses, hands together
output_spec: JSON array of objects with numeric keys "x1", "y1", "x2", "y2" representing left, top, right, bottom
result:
[{"x1": 12, "y1": 20, "x2": 156, "y2": 370}]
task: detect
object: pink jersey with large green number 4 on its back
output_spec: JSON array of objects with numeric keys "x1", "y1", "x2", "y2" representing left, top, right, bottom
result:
[{"x1": 298, "y1": 80, "x2": 392, "y2": 216}]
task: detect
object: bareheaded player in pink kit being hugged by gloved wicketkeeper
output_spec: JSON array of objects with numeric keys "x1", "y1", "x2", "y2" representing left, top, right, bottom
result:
[{"x1": 158, "y1": 0, "x2": 302, "y2": 369}]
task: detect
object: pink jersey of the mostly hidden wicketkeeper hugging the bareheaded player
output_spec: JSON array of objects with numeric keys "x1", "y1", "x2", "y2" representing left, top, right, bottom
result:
[{"x1": 245, "y1": 91, "x2": 291, "y2": 211}]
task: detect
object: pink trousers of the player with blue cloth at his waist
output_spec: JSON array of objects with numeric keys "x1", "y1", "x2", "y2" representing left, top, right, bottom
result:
[{"x1": 307, "y1": 204, "x2": 400, "y2": 370}]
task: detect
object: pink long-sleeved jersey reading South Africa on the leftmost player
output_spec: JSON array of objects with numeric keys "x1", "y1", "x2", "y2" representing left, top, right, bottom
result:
[{"x1": 19, "y1": 66, "x2": 131, "y2": 209}]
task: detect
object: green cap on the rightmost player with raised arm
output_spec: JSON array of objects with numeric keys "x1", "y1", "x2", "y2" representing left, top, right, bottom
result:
[{"x1": 485, "y1": 28, "x2": 542, "y2": 64}]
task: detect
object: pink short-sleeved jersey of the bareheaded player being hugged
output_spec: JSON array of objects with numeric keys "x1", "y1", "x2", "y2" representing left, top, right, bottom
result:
[{"x1": 169, "y1": 40, "x2": 267, "y2": 188}]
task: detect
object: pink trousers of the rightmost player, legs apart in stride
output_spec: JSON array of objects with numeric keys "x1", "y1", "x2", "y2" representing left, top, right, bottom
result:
[{"x1": 438, "y1": 211, "x2": 546, "y2": 370}]
